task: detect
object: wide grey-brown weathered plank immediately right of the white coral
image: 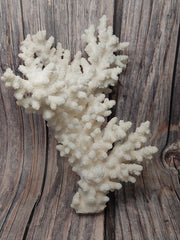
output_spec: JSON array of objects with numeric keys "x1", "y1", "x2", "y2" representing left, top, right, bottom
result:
[{"x1": 105, "y1": 0, "x2": 180, "y2": 240}]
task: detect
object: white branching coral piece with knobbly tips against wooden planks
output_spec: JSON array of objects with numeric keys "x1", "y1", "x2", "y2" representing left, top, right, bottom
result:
[{"x1": 2, "y1": 16, "x2": 157, "y2": 213}]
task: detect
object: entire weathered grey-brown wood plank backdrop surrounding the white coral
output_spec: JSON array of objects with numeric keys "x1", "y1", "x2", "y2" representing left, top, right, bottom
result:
[{"x1": 0, "y1": 0, "x2": 180, "y2": 240}]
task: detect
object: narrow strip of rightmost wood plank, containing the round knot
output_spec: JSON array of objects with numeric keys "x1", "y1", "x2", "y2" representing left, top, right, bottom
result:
[{"x1": 162, "y1": 26, "x2": 180, "y2": 238}]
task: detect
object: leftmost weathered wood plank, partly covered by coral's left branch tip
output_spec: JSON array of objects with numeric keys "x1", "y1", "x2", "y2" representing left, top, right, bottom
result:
[{"x1": 0, "y1": 1, "x2": 46, "y2": 239}]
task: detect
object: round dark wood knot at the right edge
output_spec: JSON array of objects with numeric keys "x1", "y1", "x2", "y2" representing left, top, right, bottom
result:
[{"x1": 163, "y1": 141, "x2": 180, "y2": 170}]
